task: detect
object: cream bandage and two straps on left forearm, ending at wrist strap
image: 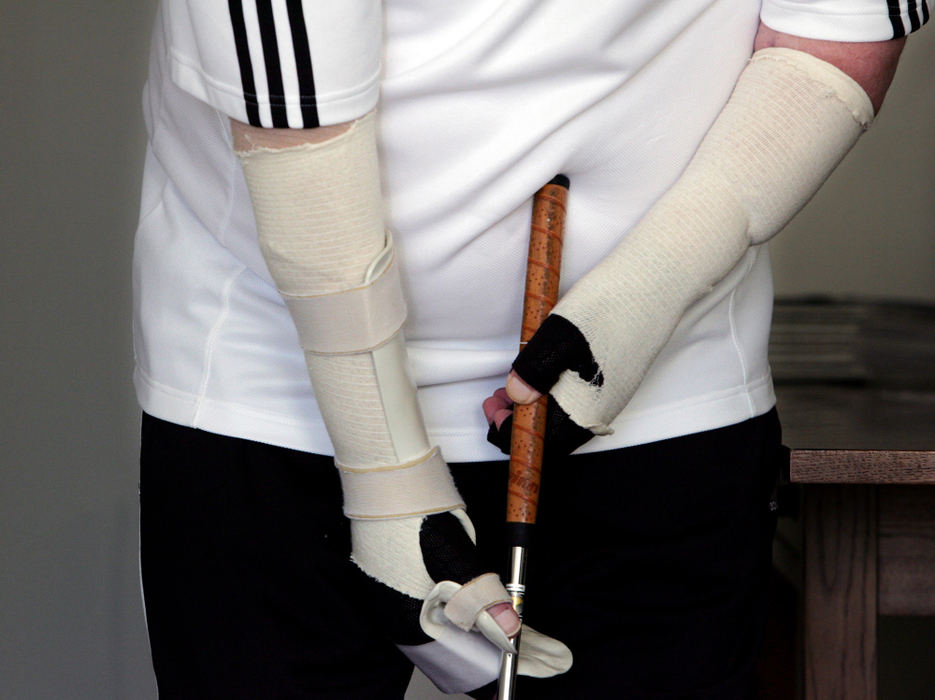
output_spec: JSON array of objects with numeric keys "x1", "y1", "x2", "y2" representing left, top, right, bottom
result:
[{"x1": 237, "y1": 113, "x2": 462, "y2": 519}]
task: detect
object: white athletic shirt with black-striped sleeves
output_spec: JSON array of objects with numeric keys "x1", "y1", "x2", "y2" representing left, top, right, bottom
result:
[{"x1": 134, "y1": 0, "x2": 928, "y2": 461}]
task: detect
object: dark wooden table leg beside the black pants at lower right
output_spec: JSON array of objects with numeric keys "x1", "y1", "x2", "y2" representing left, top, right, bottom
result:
[{"x1": 803, "y1": 485, "x2": 877, "y2": 700}]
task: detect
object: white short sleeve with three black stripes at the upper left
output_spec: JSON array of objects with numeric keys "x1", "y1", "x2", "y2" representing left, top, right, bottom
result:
[{"x1": 162, "y1": 0, "x2": 382, "y2": 128}]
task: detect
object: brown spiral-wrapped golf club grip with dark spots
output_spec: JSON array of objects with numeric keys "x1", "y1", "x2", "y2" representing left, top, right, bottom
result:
[{"x1": 506, "y1": 175, "x2": 568, "y2": 525}]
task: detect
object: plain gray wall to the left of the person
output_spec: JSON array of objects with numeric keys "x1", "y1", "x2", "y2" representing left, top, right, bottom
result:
[{"x1": 0, "y1": 0, "x2": 155, "y2": 700}]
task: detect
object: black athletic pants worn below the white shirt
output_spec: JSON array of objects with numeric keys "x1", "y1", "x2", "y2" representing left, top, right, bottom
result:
[{"x1": 140, "y1": 412, "x2": 780, "y2": 700}]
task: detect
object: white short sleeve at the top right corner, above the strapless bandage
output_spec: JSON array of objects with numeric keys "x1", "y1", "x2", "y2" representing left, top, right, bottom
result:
[{"x1": 760, "y1": 0, "x2": 933, "y2": 42}]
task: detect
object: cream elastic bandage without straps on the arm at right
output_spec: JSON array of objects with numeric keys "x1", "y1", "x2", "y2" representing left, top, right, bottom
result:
[{"x1": 551, "y1": 48, "x2": 873, "y2": 434}]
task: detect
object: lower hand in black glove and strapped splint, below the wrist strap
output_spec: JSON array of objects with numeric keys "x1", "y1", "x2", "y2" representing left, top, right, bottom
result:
[{"x1": 351, "y1": 508, "x2": 571, "y2": 693}]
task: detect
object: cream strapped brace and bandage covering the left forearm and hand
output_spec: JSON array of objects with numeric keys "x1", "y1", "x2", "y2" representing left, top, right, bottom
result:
[{"x1": 238, "y1": 115, "x2": 570, "y2": 692}]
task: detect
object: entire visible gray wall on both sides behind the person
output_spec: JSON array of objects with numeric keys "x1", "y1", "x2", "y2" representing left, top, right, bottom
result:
[{"x1": 0, "y1": 0, "x2": 935, "y2": 700}]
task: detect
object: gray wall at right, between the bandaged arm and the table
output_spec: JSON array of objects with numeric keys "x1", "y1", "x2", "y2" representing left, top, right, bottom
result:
[{"x1": 771, "y1": 27, "x2": 935, "y2": 302}]
